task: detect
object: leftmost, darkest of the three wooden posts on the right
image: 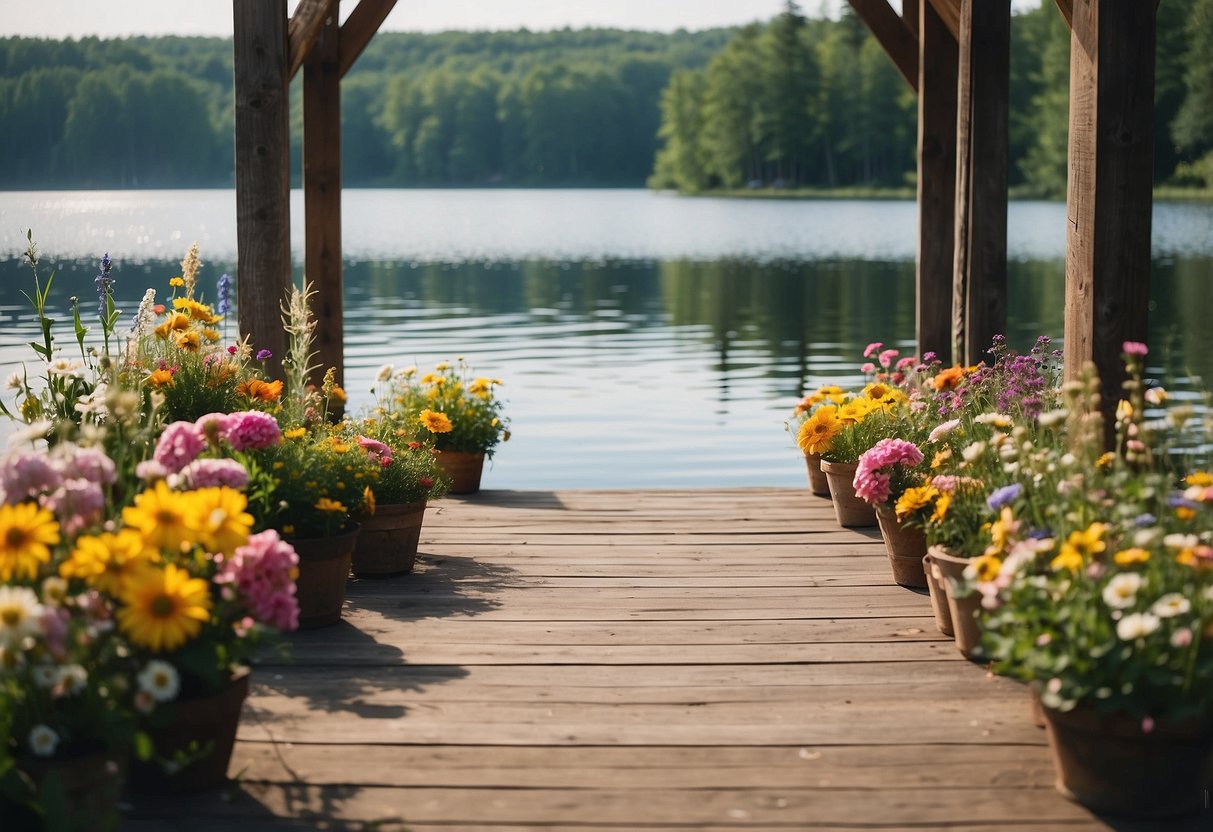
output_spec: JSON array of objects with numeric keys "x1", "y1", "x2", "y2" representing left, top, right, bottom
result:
[{"x1": 915, "y1": 1, "x2": 957, "y2": 364}]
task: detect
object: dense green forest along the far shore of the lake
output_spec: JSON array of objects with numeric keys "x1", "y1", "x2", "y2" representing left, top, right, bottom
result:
[{"x1": 0, "y1": 0, "x2": 1213, "y2": 198}]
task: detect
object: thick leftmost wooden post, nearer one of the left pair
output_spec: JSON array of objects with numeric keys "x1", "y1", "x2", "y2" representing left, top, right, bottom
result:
[{"x1": 232, "y1": 0, "x2": 291, "y2": 375}]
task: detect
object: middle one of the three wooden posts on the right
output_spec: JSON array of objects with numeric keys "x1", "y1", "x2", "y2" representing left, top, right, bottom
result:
[{"x1": 952, "y1": 0, "x2": 1010, "y2": 364}]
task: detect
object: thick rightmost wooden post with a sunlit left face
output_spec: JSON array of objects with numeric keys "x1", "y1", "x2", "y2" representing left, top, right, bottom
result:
[{"x1": 1059, "y1": 0, "x2": 1155, "y2": 446}]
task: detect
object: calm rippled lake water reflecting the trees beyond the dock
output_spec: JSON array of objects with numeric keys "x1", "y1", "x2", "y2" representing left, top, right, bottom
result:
[{"x1": 0, "y1": 190, "x2": 1213, "y2": 489}]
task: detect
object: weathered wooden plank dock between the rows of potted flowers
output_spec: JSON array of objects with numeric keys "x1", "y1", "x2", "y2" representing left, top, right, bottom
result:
[{"x1": 123, "y1": 489, "x2": 1213, "y2": 832}]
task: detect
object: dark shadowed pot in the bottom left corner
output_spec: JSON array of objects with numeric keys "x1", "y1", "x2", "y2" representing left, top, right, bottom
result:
[{"x1": 7, "y1": 748, "x2": 129, "y2": 830}]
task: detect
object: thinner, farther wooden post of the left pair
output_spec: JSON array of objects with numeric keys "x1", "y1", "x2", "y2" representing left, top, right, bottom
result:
[{"x1": 303, "y1": 10, "x2": 344, "y2": 384}]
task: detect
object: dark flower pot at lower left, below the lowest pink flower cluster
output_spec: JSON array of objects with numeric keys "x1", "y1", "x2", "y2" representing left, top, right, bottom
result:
[{"x1": 130, "y1": 669, "x2": 249, "y2": 794}]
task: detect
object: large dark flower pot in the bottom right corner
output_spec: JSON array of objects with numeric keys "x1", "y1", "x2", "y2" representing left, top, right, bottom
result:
[{"x1": 1044, "y1": 702, "x2": 1213, "y2": 819}]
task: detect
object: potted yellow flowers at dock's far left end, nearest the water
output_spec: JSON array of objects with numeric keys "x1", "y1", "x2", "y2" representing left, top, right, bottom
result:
[{"x1": 380, "y1": 358, "x2": 509, "y2": 494}]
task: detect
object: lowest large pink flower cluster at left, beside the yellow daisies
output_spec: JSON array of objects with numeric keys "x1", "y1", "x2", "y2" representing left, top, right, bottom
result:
[{"x1": 215, "y1": 529, "x2": 298, "y2": 629}]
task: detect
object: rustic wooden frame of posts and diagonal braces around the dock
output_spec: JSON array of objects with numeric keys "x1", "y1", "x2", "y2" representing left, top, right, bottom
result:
[{"x1": 233, "y1": 0, "x2": 1157, "y2": 429}]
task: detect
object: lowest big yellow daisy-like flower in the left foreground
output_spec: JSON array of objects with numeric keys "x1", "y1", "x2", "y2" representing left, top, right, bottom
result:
[{"x1": 118, "y1": 563, "x2": 211, "y2": 653}]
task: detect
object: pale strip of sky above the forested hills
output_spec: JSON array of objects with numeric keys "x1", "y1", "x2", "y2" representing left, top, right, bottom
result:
[{"x1": 2, "y1": 0, "x2": 1040, "y2": 39}]
